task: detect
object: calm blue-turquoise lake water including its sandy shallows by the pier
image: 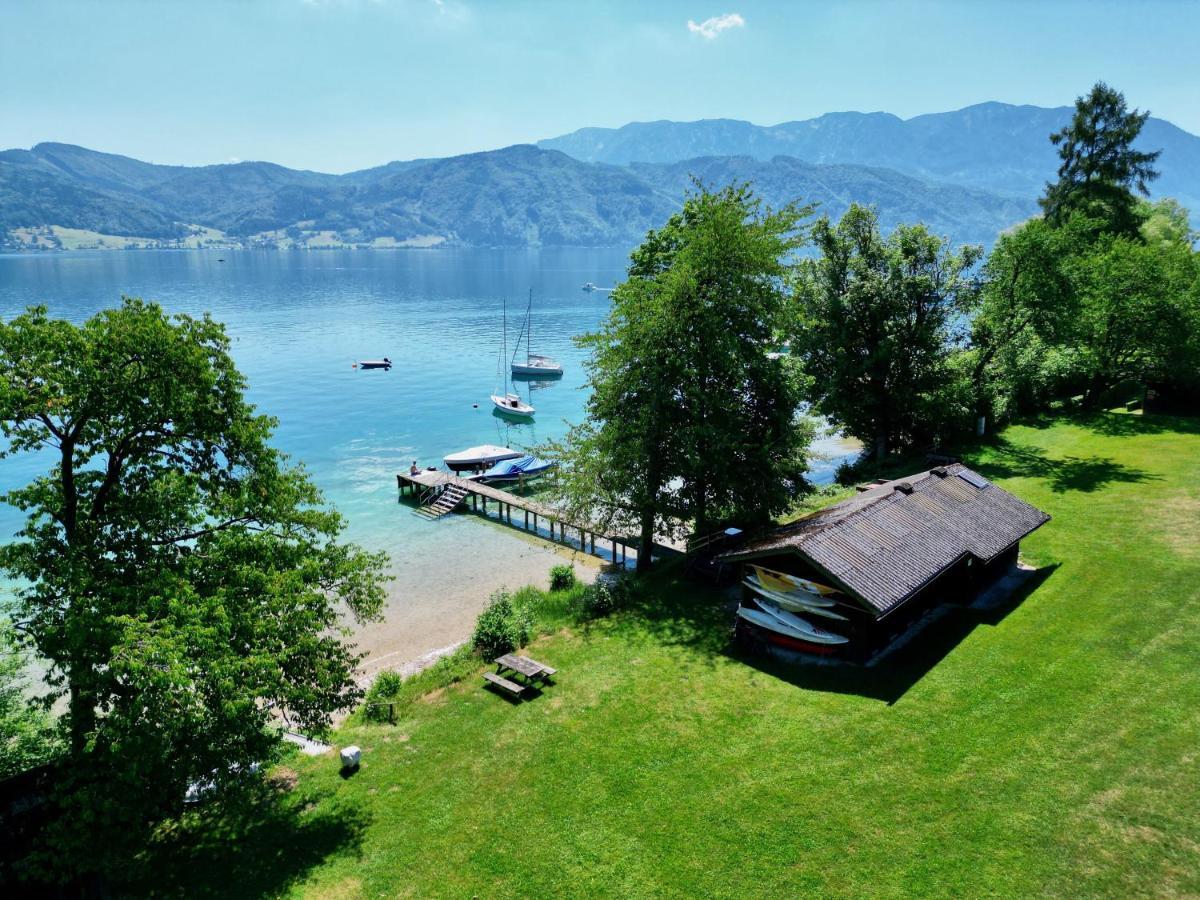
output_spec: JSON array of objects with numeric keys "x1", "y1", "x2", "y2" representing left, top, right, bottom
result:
[{"x1": 0, "y1": 250, "x2": 864, "y2": 656}]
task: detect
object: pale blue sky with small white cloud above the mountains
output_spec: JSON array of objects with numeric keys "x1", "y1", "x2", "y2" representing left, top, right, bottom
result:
[{"x1": 0, "y1": 0, "x2": 1200, "y2": 172}]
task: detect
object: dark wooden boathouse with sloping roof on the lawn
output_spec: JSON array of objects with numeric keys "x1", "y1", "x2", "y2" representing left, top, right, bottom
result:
[{"x1": 720, "y1": 463, "x2": 1050, "y2": 656}]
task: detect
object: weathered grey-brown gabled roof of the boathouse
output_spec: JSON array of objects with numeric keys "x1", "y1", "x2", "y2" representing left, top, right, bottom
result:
[{"x1": 722, "y1": 463, "x2": 1050, "y2": 616}]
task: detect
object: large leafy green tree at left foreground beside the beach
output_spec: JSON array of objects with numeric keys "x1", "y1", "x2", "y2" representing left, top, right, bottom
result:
[{"x1": 0, "y1": 299, "x2": 385, "y2": 874}]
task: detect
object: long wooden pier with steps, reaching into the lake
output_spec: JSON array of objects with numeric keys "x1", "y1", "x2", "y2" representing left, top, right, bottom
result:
[{"x1": 396, "y1": 470, "x2": 643, "y2": 566}]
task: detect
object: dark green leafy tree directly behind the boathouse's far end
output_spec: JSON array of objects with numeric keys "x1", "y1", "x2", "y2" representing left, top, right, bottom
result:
[{"x1": 793, "y1": 204, "x2": 982, "y2": 457}]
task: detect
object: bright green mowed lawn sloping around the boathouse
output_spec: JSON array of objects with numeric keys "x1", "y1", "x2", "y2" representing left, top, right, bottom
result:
[{"x1": 145, "y1": 415, "x2": 1200, "y2": 898}]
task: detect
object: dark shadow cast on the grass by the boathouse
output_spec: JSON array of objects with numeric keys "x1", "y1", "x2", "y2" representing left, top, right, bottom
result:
[{"x1": 728, "y1": 563, "x2": 1058, "y2": 706}]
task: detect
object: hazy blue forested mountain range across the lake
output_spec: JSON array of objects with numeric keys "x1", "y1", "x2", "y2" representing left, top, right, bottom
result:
[{"x1": 0, "y1": 103, "x2": 1200, "y2": 254}]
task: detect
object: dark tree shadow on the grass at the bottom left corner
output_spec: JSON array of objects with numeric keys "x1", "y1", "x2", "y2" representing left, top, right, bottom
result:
[{"x1": 126, "y1": 781, "x2": 367, "y2": 898}]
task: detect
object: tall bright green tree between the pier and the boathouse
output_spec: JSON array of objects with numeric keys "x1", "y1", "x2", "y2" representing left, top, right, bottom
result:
[{"x1": 551, "y1": 185, "x2": 811, "y2": 566}]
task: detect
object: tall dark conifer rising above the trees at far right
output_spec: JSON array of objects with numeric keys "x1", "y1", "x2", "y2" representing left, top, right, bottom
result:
[{"x1": 1040, "y1": 82, "x2": 1159, "y2": 235}]
